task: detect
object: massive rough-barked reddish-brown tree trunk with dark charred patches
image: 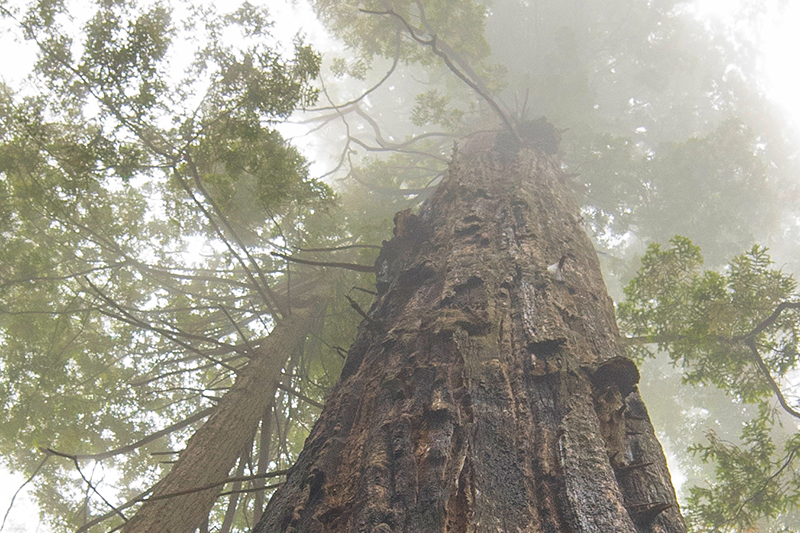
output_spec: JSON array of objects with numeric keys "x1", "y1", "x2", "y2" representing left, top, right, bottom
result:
[{"x1": 254, "y1": 149, "x2": 685, "y2": 533}]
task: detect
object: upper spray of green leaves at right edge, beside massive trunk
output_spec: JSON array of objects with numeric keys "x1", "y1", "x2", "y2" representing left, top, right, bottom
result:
[{"x1": 617, "y1": 237, "x2": 800, "y2": 402}]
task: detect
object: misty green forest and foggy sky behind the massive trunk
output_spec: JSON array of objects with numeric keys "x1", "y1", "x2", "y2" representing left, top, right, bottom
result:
[{"x1": 0, "y1": 0, "x2": 800, "y2": 533}]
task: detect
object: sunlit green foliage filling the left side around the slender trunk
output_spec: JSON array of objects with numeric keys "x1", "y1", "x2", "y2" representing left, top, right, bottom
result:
[{"x1": 0, "y1": 2, "x2": 348, "y2": 531}]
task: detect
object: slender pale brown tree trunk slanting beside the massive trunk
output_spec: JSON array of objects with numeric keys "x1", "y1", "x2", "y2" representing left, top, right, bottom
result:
[{"x1": 122, "y1": 306, "x2": 324, "y2": 533}]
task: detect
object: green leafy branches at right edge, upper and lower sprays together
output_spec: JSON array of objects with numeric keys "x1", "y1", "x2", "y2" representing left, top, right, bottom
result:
[{"x1": 617, "y1": 237, "x2": 800, "y2": 531}]
